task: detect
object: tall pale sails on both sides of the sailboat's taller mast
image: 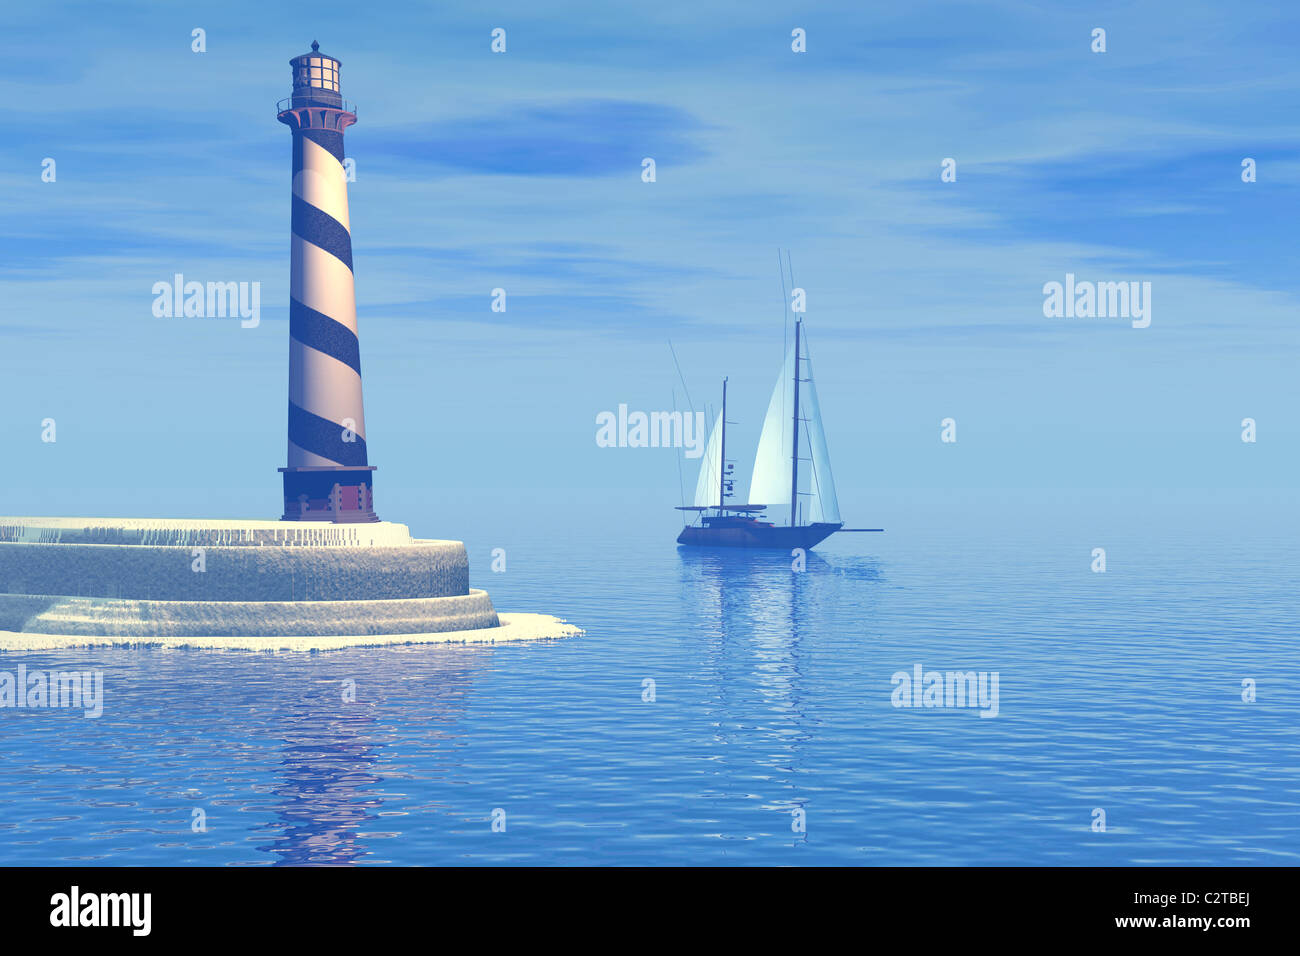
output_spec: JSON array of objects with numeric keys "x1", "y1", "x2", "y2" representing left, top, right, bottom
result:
[{"x1": 748, "y1": 329, "x2": 840, "y2": 524}]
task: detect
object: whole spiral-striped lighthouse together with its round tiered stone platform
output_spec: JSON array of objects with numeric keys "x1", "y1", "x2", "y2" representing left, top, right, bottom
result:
[{"x1": 0, "y1": 43, "x2": 581, "y2": 654}]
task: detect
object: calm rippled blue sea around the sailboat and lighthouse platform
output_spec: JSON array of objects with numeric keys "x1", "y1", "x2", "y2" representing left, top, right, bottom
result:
[{"x1": 0, "y1": 489, "x2": 1300, "y2": 866}]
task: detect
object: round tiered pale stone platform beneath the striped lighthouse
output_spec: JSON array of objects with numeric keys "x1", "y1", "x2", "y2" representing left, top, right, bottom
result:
[{"x1": 0, "y1": 518, "x2": 581, "y2": 650}]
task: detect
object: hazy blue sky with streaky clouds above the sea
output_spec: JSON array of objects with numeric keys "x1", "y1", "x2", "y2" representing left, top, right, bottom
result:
[{"x1": 0, "y1": 0, "x2": 1300, "y2": 535}]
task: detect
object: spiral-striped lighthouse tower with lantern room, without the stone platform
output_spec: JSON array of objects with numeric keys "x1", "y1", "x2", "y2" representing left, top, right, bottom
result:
[{"x1": 277, "y1": 42, "x2": 378, "y2": 522}]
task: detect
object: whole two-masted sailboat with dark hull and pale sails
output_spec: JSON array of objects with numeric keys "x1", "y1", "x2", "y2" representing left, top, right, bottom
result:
[{"x1": 677, "y1": 319, "x2": 883, "y2": 550}]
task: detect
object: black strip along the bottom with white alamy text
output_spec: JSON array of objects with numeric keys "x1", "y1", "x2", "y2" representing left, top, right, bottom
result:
[{"x1": 0, "y1": 866, "x2": 1279, "y2": 952}]
